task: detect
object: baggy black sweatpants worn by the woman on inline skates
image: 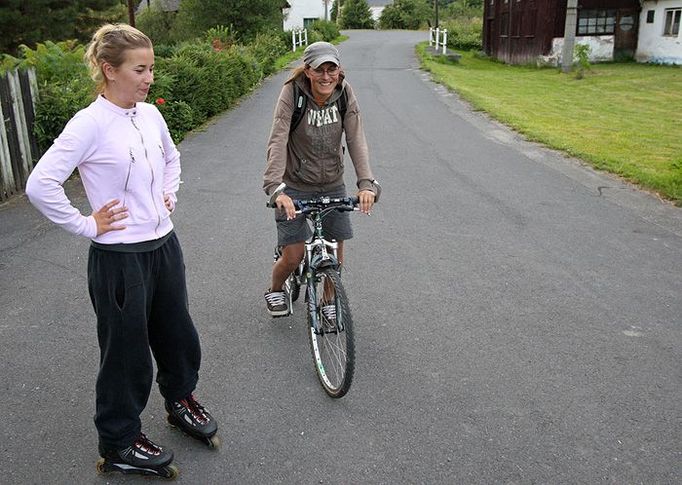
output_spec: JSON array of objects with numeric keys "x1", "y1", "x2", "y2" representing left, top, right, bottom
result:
[{"x1": 88, "y1": 233, "x2": 201, "y2": 449}]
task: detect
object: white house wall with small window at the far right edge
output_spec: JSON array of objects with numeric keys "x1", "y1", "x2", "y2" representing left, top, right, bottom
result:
[{"x1": 635, "y1": 0, "x2": 682, "y2": 64}]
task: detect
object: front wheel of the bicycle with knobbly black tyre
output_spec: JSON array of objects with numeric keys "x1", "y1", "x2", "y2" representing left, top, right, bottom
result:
[{"x1": 308, "y1": 268, "x2": 355, "y2": 398}]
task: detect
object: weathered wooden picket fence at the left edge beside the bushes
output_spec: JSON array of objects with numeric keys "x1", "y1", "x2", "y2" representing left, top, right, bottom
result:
[{"x1": 0, "y1": 69, "x2": 39, "y2": 202}]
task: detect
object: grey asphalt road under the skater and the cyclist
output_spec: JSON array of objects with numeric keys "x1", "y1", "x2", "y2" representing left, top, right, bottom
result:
[{"x1": 0, "y1": 31, "x2": 682, "y2": 484}]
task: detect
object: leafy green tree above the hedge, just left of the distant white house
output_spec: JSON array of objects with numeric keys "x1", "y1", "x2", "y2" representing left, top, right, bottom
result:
[{"x1": 178, "y1": 0, "x2": 283, "y2": 40}]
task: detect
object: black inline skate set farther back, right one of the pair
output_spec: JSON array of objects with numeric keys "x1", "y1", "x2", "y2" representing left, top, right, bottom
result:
[{"x1": 166, "y1": 394, "x2": 220, "y2": 448}]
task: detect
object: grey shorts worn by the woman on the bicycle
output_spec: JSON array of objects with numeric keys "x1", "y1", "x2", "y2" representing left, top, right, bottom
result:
[{"x1": 275, "y1": 185, "x2": 353, "y2": 246}]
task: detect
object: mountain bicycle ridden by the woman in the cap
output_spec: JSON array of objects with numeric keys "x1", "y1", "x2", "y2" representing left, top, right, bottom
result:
[{"x1": 266, "y1": 181, "x2": 381, "y2": 398}]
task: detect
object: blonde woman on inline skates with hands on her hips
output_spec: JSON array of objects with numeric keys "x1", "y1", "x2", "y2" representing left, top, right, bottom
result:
[{"x1": 26, "y1": 24, "x2": 217, "y2": 477}]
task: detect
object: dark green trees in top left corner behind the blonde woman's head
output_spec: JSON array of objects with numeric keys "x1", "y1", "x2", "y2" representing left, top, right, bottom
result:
[{"x1": 0, "y1": 0, "x2": 127, "y2": 54}]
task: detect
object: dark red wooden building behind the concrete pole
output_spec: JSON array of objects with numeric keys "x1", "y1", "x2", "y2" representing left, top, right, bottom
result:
[{"x1": 483, "y1": 0, "x2": 640, "y2": 64}]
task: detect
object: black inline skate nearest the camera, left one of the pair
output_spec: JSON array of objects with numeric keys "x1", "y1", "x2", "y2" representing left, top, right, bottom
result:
[{"x1": 97, "y1": 433, "x2": 178, "y2": 480}]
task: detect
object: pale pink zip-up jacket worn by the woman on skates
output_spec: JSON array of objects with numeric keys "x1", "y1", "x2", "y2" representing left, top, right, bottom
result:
[{"x1": 26, "y1": 96, "x2": 180, "y2": 244}]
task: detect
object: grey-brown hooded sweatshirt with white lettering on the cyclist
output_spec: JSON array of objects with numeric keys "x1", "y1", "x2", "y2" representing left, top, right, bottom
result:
[{"x1": 263, "y1": 73, "x2": 376, "y2": 195}]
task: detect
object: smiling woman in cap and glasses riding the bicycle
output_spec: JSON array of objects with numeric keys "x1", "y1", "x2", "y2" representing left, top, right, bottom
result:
[{"x1": 263, "y1": 42, "x2": 377, "y2": 317}]
